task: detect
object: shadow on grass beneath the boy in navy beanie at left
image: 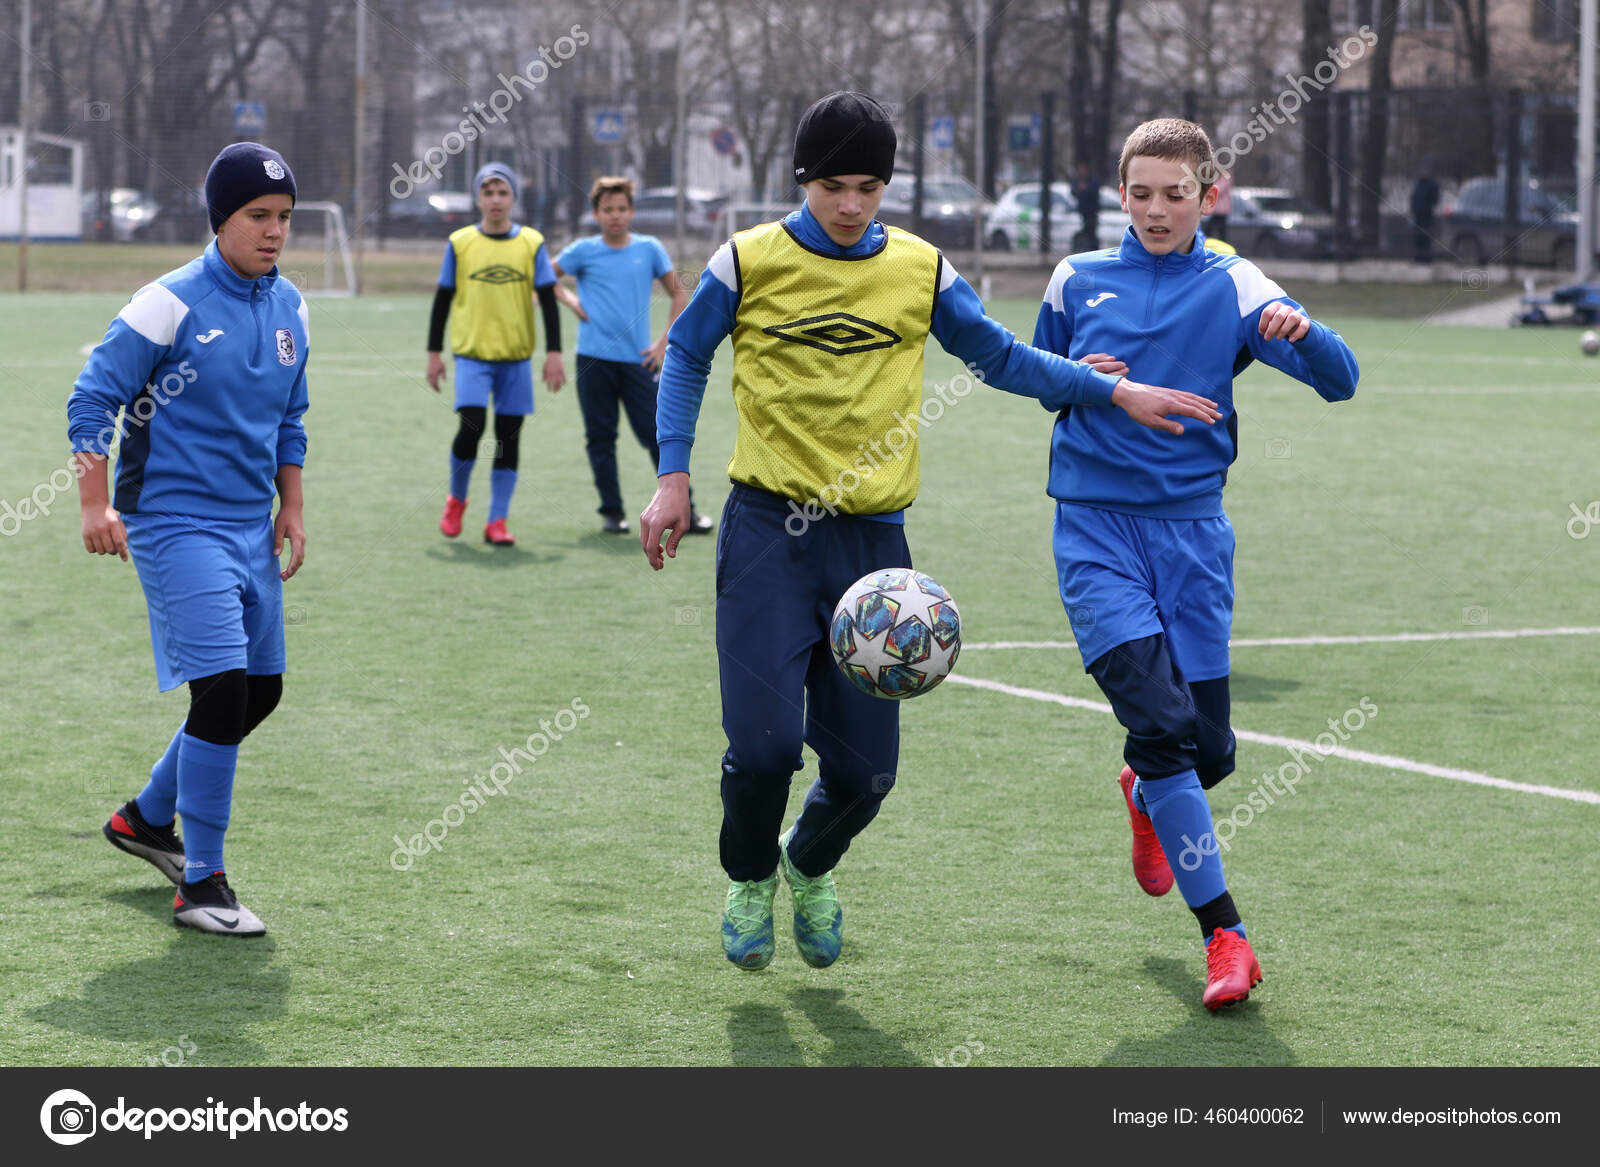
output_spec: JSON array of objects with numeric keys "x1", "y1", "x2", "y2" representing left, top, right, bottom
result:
[{"x1": 27, "y1": 888, "x2": 290, "y2": 1066}]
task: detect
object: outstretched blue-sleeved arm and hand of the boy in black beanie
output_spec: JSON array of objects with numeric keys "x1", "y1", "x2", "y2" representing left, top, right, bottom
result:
[{"x1": 933, "y1": 259, "x2": 1222, "y2": 434}]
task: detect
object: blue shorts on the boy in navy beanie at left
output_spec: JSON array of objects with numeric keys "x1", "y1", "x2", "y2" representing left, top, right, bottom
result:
[{"x1": 122, "y1": 514, "x2": 288, "y2": 693}]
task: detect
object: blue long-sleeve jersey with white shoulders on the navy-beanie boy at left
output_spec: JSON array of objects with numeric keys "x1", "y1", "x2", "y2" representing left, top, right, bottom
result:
[{"x1": 67, "y1": 240, "x2": 309, "y2": 520}]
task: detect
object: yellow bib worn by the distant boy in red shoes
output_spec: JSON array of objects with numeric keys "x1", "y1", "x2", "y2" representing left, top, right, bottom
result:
[{"x1": 450, "y1": 226, "x2": 544, "y2": 360}]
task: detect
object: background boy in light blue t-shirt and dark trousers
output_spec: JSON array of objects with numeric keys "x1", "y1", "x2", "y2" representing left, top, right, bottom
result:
[{"x1": 555, "y1": 178, "x2": 712, "y2": 535}]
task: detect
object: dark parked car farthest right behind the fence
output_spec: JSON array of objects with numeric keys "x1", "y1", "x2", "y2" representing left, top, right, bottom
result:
[{"x1": 1435, "y1": 178, "x2": 1578, "y2": 271}]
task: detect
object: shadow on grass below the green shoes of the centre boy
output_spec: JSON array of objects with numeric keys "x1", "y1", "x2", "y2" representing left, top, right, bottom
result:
[{"x1": 728, "y1": 989, "x2": 928, "y2": 1066}]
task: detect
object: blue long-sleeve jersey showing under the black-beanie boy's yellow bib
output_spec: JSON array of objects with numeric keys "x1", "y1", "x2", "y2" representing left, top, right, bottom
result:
[{"x1": 656, "y1": 207, "x2": 1120, "y2": 499}]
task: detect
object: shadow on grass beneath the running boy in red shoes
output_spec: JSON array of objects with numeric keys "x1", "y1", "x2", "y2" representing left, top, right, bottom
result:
[{"x1": 1101, "y1": 956, "x2": 1299, "y2": 1066}]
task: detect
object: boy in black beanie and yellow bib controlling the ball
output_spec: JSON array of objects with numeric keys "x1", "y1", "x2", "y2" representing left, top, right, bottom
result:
[{"x1": 640, "y1": 93, "x2": 1218, "y2": 968}]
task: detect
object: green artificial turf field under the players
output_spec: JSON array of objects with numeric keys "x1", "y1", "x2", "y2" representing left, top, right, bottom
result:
[{"x1": 0, "y1": 257, "x2": 1600, "y2": 1066}]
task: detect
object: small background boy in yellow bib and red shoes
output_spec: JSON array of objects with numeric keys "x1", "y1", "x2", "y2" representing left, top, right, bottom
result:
[{"x1": 427, "y1": 162, "x2": 566, "y2": 547}]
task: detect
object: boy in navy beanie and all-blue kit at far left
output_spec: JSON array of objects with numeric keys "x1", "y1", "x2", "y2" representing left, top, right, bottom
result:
[{"x1": 67, "y1": 142, "x2": 307, "y2": 936}]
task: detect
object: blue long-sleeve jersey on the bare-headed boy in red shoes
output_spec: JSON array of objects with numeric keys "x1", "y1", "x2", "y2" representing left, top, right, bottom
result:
[{"x1": 1034, "y1": 227, "x2": 1360, "y2": 519}]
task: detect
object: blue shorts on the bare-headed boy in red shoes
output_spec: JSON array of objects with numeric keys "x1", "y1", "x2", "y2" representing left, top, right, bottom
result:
[{"x1": 1054, "y1": 503, "x2": 1234, "y2": 682}]
